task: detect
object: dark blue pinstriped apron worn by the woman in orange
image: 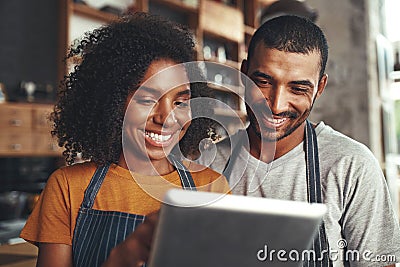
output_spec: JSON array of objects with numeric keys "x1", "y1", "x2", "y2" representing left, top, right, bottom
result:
[{"x1": 72, "y1": 156, "x2": 196, "y2": 267}]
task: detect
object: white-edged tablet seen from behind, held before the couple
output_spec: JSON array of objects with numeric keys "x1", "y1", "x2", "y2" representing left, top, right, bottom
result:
[{"x1": 149, "y1": 189, "x2": 326, "y2": 267}]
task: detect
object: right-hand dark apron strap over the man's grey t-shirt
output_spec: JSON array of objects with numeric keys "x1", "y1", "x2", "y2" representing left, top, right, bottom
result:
[{"x1": 303, "y1": 120, "x2": 332, "y2": 266}]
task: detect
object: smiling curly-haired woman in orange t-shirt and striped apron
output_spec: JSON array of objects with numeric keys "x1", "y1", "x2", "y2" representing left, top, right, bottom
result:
[{"x1": 21, "y1": 14, "x2": 229, "y2": 266}]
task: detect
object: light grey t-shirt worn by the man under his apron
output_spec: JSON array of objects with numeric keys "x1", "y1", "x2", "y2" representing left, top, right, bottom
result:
[{"x1": 198, "y1": 122, "x2": 400, "y2": 266}]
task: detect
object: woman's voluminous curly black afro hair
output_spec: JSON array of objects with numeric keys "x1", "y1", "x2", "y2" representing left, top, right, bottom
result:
[{"x1": 51, "y1": 13, "x2": 217, "y2": 168}]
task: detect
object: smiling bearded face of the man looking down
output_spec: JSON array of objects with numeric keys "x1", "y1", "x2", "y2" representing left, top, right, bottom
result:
[{"x1": 242, "y1": 42, "x2": 326, "y2": 142}]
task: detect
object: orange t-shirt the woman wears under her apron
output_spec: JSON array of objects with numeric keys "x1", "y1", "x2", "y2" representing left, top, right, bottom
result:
[{"x1": 20, "y1": 162, "x2": 230, "y2": 245}]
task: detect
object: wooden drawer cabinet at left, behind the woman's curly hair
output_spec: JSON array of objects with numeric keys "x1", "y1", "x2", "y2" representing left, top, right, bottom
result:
[{"x1": 0, "y1": 103, "x2": 62, "y2": 156}]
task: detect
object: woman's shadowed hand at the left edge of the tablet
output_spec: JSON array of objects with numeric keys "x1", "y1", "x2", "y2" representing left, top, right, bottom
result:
[{"x1": 102, "y1": 212, "x2": 158, "y2": 267}]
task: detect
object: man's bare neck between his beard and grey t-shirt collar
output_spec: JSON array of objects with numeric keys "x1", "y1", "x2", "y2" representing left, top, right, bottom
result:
[{"x1": 247, "y1": 122, "x2": 306, "y2": 163}]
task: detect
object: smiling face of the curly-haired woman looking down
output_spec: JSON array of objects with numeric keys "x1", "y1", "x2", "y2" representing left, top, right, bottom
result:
[{"x1": 123, "y1": 59, "x2": 191, "y2": 171}]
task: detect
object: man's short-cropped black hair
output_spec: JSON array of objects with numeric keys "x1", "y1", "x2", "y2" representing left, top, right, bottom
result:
[{"x1": 247, "y1": 15, "x2": 328, "y2": 78}]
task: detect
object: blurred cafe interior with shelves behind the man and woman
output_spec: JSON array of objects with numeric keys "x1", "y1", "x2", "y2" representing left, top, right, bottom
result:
[{"x1": 0, "y1": 0, "x2": 400, "y2": 266}]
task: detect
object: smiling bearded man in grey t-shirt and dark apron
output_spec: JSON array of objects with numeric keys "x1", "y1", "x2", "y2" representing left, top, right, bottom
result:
[{"x1": 205, "y1": 15, "x2": 400, "y2": 266}]
